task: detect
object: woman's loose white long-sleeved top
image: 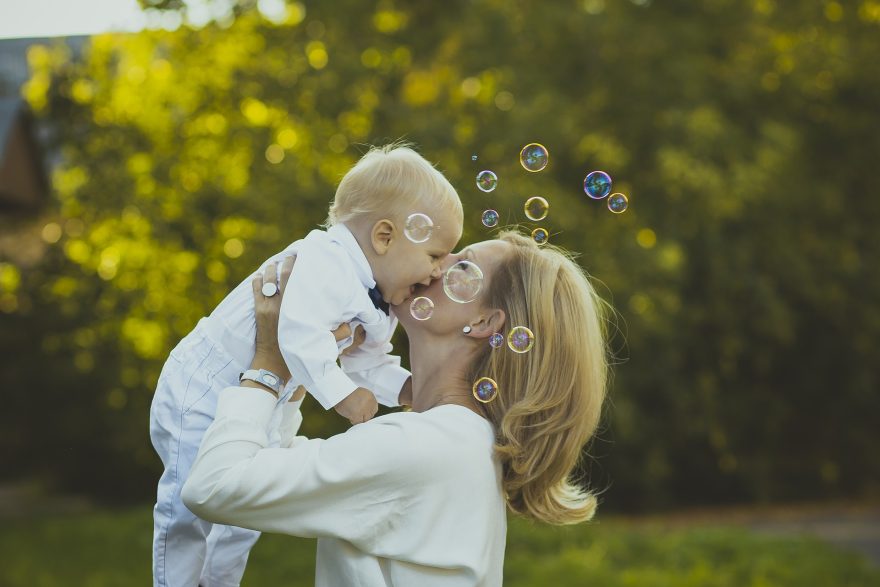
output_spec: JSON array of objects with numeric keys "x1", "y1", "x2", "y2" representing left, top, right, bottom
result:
[{"x1": 182, "y1": 387, "x2": 507, "y2": 587}]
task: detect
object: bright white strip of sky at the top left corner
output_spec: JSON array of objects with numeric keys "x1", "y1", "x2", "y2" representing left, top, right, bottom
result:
[{"x1": 0, "y1": 0, "x2": 286, "y2": 39}]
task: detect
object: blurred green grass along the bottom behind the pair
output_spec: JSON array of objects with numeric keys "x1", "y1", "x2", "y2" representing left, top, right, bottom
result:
[{"x1": 0, "y1": 507, "x2": 880, "y2": 587}]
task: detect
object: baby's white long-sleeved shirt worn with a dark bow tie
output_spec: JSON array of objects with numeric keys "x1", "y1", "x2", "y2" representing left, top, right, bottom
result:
[{"x1": 208, "y1": 224, "x2": 409, "y2": 409}]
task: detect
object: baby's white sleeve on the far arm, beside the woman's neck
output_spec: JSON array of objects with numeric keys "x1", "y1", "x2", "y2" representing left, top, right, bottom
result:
[{"x1": 339, "y1": 341, "x2": 410, "y2": 407}]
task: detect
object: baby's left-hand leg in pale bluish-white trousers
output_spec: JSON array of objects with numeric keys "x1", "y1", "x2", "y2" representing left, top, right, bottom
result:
[{"x1": 150, "y1": 333, "x2": 231, "y2": 587}]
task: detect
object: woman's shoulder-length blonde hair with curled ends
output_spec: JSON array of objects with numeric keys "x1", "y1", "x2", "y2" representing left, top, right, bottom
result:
[{"x1": 469, "y1": 231, "x2": 610, "y2": 524}]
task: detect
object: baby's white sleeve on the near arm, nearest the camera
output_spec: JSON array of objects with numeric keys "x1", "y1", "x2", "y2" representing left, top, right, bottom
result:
[{"x1": 278, "y1": 244, "x2": 358, "y2": 410}]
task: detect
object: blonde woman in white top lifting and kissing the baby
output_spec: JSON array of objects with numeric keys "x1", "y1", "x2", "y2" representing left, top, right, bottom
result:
[{"x1": 183, "y1": 232, "x2": 607, "y2": 587}]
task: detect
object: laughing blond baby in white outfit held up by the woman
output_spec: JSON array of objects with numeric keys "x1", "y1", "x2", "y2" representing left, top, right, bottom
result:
[{"x1": 150, "y1": 145, "x2": 463, "y2": 587}]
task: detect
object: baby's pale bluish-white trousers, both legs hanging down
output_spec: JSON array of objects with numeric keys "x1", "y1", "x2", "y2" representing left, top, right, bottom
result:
[{"x1": 150, "y1": 324, "x2": 276, "y2": 587}]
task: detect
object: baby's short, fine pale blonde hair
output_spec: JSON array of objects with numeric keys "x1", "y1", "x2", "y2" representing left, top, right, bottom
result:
[{"x1": 324, "y1": 142, "x2": 464, "y2": 228}]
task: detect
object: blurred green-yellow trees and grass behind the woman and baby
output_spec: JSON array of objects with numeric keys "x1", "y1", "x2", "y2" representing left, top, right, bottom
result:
[{"x1": 0, "y1": 0, "x2": 880, "y2": 585}]
